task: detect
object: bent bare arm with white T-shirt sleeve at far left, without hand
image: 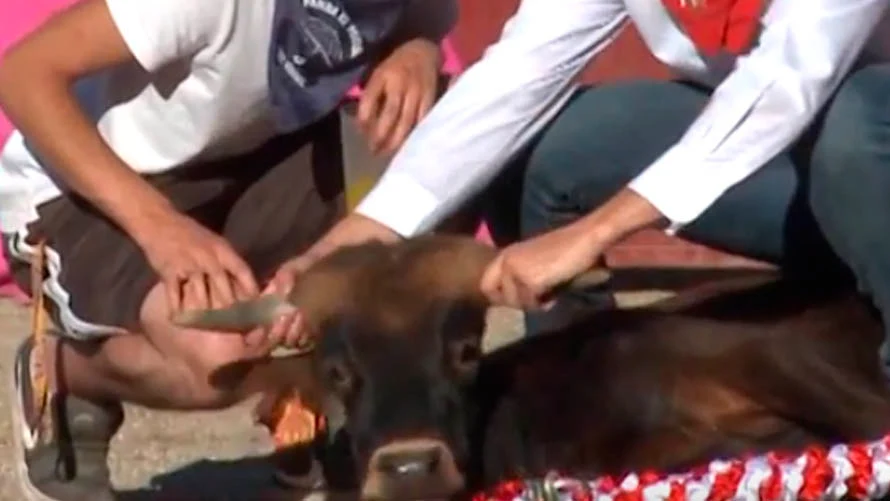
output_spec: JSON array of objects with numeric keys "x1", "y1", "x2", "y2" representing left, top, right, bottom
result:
[{"x1": 0, "y1": 0, "x2": 230, "y2": 244}]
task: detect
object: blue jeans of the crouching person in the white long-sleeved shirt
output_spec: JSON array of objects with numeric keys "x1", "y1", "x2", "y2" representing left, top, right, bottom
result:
[{"x1": 489, "y1": 65, "x2": 890, "y2": 361}]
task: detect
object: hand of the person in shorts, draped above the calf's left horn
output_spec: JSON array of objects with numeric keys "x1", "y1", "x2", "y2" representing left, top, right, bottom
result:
[{"x1": 140, "y1": 214, "x2": 259, "y2": 313}]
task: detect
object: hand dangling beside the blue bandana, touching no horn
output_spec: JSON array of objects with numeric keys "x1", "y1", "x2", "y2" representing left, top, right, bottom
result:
[{"x1": 357, "y1": 39, "x2": 441, "y2": 154}]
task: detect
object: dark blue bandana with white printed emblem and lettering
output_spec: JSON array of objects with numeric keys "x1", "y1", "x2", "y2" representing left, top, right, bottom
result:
[{"x1": 268, "y1": 0, "x2": 405, "y2": 132}]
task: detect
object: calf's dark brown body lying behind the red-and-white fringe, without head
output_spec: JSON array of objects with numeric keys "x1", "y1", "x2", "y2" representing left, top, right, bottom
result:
[{"x1": 478, "y1": 282, "x2": 890, "y2": 475}]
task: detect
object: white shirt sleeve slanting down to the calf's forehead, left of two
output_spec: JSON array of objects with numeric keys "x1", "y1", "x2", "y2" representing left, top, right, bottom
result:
[{"x1": 356, "y1": 0, "x2": 626, "y2": 236}]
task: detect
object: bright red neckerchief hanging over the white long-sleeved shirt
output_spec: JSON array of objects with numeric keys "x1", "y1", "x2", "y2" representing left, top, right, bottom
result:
[{"x1": 663, "y1": 0, "x2": 766, "y2": 55}]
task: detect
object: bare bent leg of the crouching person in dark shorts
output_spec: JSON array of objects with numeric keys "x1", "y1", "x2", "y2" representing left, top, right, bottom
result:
[{"x1": 46, "y1": 286, "x2": 312, "y2": 410}]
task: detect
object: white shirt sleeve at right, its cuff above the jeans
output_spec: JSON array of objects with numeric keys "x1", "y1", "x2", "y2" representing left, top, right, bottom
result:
[{"x1": 630, "y1": 0, "x2": 888, "y2": 230}]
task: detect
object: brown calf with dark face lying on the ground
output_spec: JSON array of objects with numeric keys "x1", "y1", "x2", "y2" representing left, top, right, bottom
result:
[{"x1": 177, "y1": 237, "x2": 890, "y2": 500}]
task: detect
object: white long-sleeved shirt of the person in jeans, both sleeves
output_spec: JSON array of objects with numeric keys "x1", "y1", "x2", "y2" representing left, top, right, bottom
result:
[{"x1": 356, "y1": 0, "x2": 890, "y2": 236}]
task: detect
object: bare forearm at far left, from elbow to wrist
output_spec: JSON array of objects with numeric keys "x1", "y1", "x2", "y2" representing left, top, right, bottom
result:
[{"x1": 0, "y1": 55, "x2": 175, "y2": 241}]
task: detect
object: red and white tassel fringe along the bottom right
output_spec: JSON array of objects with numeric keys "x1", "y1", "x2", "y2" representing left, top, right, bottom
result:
[{"x1": 473, "y1": 435, "x2": 890, "y2": 501}]
